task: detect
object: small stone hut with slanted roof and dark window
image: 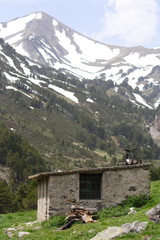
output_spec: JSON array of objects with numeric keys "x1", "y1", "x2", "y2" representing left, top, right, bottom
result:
[{"x1": 29, "y1": 163, "x2": 150, "y2": 221}]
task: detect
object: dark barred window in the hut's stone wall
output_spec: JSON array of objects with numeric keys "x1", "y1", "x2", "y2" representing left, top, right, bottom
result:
[{"x1": 80, "y1": 174, "x2": 102, "y2": 199}]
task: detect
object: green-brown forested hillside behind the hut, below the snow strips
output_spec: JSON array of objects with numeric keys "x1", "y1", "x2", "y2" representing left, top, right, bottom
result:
[{"x1": 0, "y1": 75, "x2": 160, "y2": 169}]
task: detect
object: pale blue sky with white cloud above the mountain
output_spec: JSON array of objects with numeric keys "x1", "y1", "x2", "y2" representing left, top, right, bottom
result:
[{"x1": 0, "y1": 0, "x2": 160, "y2": 48}]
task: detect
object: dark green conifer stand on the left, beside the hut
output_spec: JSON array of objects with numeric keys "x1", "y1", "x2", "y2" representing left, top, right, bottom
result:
[{"x1": 0, "y1": 124, "x2": 46, "y2": 213}]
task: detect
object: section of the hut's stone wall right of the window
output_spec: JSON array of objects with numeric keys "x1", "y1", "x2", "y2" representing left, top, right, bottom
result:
[{"x1": 102, "y1": 168, "x2": 150, "y2": 206}]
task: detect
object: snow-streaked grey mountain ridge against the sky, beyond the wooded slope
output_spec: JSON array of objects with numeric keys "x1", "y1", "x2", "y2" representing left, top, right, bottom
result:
[{"x1": 0, "y1": 12, "x2": 160, "y2": 107}]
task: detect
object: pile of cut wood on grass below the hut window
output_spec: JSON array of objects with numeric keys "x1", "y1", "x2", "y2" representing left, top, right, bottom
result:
[{"x1": 61, "y1": 206, "x2": 97, "y2": 230}]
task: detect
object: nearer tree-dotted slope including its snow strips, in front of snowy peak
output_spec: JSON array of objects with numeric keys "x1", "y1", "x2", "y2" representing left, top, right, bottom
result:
[{"x1": 0, "y1": 29, "x2": 159, "y2": 163}]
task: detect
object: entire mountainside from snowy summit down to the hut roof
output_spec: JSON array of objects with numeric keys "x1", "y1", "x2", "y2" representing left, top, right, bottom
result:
[{"x1": 0, "y1": 12, "x2": 160, "y2": 169}]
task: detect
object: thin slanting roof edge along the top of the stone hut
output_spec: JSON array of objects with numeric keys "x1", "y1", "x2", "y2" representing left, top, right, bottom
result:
[{"x1": 28, "y1": 163, "x2": 150, "y2": 179}]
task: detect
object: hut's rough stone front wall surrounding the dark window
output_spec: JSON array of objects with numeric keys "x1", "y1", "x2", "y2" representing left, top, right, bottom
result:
[{"x1": 45, "y1": 166, "x2": 150, "y2": 216}]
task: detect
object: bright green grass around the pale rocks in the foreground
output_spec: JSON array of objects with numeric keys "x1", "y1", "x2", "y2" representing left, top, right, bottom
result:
[{"x1": 0, "y1": 181, "x2": 160, "y2": 240}]
